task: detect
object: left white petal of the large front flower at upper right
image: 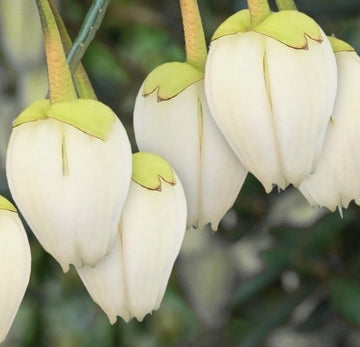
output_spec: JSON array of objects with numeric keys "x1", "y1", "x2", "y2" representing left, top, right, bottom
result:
[{"x1": 205, "y1": 32, "x2": 285, "y2": 192}]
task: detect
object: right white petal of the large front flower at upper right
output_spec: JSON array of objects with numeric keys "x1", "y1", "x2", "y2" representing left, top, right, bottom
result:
[{"x1": 264, "y1": 33, "x2": 337, "y2": 186}]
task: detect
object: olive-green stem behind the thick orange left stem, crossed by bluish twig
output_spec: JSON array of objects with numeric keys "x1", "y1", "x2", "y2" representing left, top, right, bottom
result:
[{"x1": 48, "y1": 0, "x2": 97, "y2": 100}]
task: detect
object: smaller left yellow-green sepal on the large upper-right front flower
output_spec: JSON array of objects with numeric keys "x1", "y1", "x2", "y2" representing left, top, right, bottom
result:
[{"x1": 211, "y1": 10, "x2": 251, "y2": 41}]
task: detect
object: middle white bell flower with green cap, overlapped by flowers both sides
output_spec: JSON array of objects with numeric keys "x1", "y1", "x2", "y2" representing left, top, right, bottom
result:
[{"x1": 134, "y1": 62, "x2": 247, "y2": 230}]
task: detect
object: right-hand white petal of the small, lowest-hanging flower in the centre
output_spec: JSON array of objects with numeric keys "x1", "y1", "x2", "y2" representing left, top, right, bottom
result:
[{"x1": 119, "y1": 177, "x2": 186, "y2": 321}]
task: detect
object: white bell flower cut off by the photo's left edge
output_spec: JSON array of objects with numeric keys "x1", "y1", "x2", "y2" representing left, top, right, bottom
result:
[{"x1": 0, "y1": 196, "x2": 31, "y2": 343}]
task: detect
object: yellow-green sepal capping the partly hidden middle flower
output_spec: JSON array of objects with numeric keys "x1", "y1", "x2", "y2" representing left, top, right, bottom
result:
[{"x1": 142, "y1": 62, "x2": 204, "y2": 101}]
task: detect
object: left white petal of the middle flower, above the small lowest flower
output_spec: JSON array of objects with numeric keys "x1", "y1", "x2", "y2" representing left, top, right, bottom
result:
[{"x1": 134, "y1": 84, "x2": 200, "y2": 226}]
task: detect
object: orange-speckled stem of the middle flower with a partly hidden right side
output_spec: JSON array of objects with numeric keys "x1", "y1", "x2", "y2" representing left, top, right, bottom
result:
[{"x1": 180, "y1": 0, "x2": 207, "y2": 71}]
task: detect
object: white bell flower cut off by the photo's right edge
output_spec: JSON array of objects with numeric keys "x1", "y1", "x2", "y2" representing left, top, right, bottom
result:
[{"x1": 299, "y1": 38, "x2": 360, "y2": 211}]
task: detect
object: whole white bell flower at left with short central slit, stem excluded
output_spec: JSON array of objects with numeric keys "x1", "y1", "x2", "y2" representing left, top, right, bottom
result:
[{"x1": 7, "y1": 99, "x2": 131, "y2": 272}]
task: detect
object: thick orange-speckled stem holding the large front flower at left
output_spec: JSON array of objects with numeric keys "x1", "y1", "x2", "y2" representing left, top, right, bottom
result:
[{"x1": 36, "y1": 0, "x2": 76, "y2": 103}]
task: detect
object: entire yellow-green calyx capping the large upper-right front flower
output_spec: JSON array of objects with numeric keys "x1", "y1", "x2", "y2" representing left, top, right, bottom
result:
[{"x1": 212, "y1": 10, "x2": 323, "y2": 49}]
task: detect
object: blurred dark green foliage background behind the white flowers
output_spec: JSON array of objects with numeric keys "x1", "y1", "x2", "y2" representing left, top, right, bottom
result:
[{"x1": 0, "y1": 0, "x2": 360, "y2": 347}]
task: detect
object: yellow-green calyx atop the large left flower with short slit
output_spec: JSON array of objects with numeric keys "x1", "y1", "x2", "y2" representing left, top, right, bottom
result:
[{"x1": 13, "y1": 99, "x2": 116, "y2": 141}]
